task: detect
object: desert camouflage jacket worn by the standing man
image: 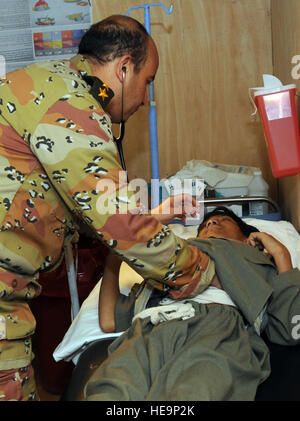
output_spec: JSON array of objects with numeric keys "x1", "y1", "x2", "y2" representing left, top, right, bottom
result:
[{"x1": 0, "y1": 55, "x2": 210, "y2": 339}]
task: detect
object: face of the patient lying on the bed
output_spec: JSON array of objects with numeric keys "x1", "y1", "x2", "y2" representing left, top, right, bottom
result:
[{"x1": 198, "y1": 215, "x2": 247, "y2": 241}]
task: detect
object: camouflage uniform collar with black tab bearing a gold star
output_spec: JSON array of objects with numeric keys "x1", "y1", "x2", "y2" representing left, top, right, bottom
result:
[{"x1": 71, "y1": 54, "x2": 114, "y2": 109}]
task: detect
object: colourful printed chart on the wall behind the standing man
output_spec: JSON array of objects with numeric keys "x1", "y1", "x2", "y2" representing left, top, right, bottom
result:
[{"x1": 0, "y1": 0, "x2": 93, "y2": 77}]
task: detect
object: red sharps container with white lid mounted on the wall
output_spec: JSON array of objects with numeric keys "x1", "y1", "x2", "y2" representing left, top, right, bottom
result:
[{"x1": 252, "y1": 75, "x2": 300, "y2": 178}]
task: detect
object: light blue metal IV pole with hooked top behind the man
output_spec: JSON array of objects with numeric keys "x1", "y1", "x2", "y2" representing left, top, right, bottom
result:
[{"x1": 126, "y1": 3, "x2": 173, "y2": 208}]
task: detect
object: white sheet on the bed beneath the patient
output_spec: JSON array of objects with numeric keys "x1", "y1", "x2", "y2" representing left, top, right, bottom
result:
[{"x1": 53, "y1": 218, "x2": 300, "y2": 364}]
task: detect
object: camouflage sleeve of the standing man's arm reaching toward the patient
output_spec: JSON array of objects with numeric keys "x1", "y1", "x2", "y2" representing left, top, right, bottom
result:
[{"x1": 30, "y1": 94, "x2": 210, "y2": 298}]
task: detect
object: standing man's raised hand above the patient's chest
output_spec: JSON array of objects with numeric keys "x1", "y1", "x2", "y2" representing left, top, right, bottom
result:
[{"x1": 151, "y1": 194, "x2": 200, "y2": 224}]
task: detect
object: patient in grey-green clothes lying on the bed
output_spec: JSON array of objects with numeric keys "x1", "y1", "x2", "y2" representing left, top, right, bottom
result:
[{"x1": 85, "y1": 208, "x2": 300, "y2": 401}]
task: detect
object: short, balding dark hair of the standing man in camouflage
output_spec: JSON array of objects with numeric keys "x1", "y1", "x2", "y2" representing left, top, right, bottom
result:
[{"x1": 78, "y1": 15, "x2": 149, "y2": 73}]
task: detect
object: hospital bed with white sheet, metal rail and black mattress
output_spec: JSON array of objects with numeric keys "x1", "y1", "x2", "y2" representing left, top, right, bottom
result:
[{"x1": 53, "y1": 197, "x2": 300, "y2": 401}]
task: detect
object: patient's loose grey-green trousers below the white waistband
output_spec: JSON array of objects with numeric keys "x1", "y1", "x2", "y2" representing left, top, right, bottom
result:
[{"x1": 86, "y1": 303, "x2": 270, "y2": 401}]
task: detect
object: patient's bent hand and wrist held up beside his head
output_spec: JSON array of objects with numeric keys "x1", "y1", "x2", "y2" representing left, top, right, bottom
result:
[{"x1": 246, "y1": 232, "x2": 293, "y2": 273}]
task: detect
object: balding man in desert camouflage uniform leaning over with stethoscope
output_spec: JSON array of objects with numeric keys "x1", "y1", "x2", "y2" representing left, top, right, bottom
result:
[{"x1": 0, "y1": 16, "x2": 209, "y2": 401}]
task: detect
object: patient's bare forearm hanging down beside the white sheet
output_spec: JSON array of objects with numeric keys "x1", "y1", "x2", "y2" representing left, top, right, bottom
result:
[{"x1": 99, "y1": 253, "x2": 122, "y2": 333}]
